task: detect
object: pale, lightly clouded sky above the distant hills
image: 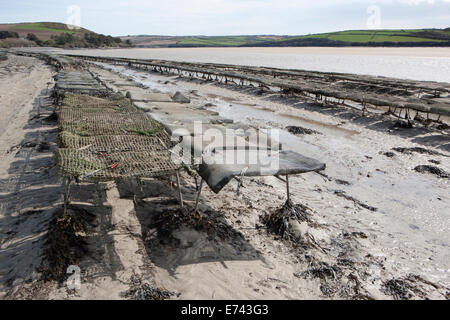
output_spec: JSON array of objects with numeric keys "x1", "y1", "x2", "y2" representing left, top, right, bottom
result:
[{"x1": 0, "y1": 0, "x2": 450, "y2": 36}]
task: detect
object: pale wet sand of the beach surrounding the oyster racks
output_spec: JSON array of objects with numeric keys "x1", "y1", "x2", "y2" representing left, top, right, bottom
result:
[{"x1": 0, "y1": 52, "x2": 450, "y2": 300}]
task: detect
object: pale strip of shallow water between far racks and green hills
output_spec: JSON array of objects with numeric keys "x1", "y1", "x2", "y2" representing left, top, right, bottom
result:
[{"x1": 47, "y1": 48, "x2": 450, "y2": 82}]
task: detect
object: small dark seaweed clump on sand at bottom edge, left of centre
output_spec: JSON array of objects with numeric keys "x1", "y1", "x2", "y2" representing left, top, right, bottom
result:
[{"x1": 123, "y1": 275, "x2": 175, "y2": 300}]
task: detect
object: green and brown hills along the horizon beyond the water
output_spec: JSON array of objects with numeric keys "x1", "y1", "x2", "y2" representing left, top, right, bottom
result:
[{"x1": 0, "y1": 22, "x2": 450, "y2": 48}]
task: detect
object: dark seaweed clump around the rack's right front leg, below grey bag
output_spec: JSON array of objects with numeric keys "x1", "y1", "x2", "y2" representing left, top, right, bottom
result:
[{"x1": 261, "y1": 200, "x2": 311, "y2": 240}]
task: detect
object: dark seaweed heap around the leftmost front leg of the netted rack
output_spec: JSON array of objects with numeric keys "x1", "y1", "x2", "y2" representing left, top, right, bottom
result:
[{"x1": 41, "y1": 205, "x2": 95, "y2": 282}]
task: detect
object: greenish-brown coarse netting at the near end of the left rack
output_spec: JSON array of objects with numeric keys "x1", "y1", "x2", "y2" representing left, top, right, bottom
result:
[{"x1": 56, "y1": 93, "x2": 178, "y2": 181}]
